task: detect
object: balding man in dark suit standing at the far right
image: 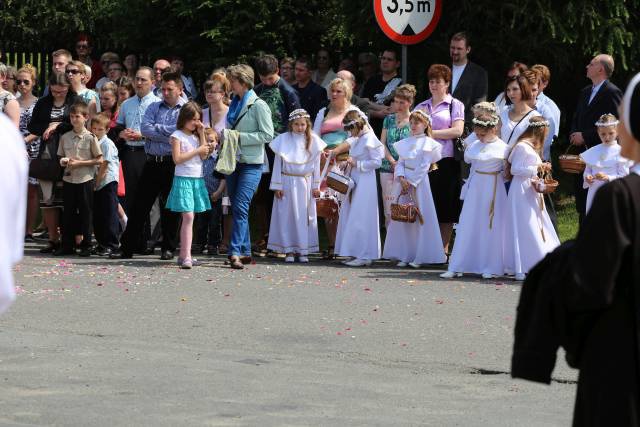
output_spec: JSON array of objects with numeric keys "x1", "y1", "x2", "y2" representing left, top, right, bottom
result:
[{"x1": 569, "y1": 54, "x2": 622, "y2": 224}]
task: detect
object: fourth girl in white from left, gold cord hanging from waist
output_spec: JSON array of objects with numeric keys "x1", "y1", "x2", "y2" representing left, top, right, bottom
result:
[{"x1": 440, "y1": 108, "x2": 509, "y2": 279}]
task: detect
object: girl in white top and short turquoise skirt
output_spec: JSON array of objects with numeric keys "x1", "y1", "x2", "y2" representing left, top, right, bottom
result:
[{"x1": 166, "y1": 101, "x2": 215, "y2": 269}]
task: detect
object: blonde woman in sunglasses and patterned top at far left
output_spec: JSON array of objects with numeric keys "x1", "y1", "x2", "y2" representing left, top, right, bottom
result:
[{"x1": 16, "y1": 64, "x2": 40, "y2": 241}]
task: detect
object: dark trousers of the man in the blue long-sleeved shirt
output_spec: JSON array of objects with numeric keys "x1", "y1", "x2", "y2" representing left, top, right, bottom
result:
[{"x1": 120, "y1": 156, "x2": 180, "y2": 255}]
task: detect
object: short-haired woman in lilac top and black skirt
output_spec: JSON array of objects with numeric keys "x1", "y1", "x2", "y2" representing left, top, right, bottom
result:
[{"x1": 415, "y1": 64, "x2": 464, "y2": 254}]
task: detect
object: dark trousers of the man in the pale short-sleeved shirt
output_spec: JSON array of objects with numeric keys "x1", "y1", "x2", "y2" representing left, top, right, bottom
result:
[{"x1": 119, "y1": 145, "x2": 151, "y2": 251}]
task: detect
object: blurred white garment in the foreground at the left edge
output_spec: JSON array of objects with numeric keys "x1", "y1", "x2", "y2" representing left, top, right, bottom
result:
[{"x1": 0, "y1": 114, "x2": 29, "y2": 313}]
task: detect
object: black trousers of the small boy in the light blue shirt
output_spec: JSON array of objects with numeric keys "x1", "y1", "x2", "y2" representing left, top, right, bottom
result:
[{"x1": 93, "y1": 181, "x2": 120, "y2": 250}]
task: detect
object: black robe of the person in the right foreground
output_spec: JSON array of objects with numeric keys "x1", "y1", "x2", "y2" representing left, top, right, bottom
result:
[{"x1": 512, "y1": 174, "x2": 640, "y2": 426}]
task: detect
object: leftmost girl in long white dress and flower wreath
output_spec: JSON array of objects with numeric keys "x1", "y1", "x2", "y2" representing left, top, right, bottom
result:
[{"x1": 267, "y1": 109, "x2": 327, "y2": 263}]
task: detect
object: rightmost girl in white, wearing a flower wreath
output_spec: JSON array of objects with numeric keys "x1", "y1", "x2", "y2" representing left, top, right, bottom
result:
[{"x1": 580, "y1": 114, "x2": 629, "y2": 212}]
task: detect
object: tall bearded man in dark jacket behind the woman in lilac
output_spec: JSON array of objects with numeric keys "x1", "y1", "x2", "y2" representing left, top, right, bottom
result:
[{"x1": 449, "y1": 32, "x2": 489, "y2": 134}]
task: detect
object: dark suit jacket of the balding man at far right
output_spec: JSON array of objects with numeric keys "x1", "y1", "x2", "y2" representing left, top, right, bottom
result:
[{"x1": 570, "y1": 80, "x2": 622, "y2": 148}]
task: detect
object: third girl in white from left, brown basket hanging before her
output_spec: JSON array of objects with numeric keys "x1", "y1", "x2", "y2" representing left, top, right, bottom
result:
[{"x1": 384, "y1": 110, "x2": 447, "y2": 268}]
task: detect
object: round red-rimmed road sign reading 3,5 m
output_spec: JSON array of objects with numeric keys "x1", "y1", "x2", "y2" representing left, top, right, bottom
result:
[{"x1": 373, "y1": 0, "x2": 442, "y2": 45}]
